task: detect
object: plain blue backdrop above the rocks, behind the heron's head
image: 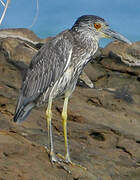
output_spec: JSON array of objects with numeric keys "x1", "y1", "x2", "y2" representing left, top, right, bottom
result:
[{"x1": 0, "y1": 0, "x2": 140, "y2": 45}]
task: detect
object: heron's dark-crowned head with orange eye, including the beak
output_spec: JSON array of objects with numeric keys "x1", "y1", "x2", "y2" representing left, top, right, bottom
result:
[{"x1": 72, "y1": 15, "x2": 131, "y2": 44}]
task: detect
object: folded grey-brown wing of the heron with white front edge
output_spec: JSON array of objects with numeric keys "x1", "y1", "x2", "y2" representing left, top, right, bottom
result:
[{"x1": 19, "y1": 33, "x2": 72, "y2": 104}]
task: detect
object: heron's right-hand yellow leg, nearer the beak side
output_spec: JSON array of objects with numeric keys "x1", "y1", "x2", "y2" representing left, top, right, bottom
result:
[{"x1": 62, "y1": 96, "x2": 71, "y2": 162}]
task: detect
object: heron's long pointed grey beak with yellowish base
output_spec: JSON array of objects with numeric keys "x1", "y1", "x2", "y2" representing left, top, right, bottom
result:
[{"x1": 102, "y1": 28, "x2": 131, "y2": 44}]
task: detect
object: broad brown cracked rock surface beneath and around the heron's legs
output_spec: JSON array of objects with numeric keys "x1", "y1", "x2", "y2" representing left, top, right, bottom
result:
[{"x1": 0, "y1": 28, "x2": 140, "y2": 180}]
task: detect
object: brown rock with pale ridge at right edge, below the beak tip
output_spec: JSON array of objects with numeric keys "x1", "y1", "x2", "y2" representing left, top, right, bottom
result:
[{"x1": 100, "y1": 41, "x2": 140, "y2": 80}]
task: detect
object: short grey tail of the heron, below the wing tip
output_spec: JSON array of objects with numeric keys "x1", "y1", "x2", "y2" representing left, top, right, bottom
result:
[{"x1": 13, "y1": 102, "x2": 35, "y2": 123}]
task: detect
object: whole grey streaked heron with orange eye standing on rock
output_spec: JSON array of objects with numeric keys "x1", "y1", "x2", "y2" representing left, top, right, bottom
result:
[{"x1": 14, "y1": 15, "x2": 130, "y2": 165}]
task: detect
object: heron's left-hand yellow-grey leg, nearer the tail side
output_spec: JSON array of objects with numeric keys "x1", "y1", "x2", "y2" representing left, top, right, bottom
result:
[{"x1": 46, "y1": 99, "x2": 57, "y2": 163}]
